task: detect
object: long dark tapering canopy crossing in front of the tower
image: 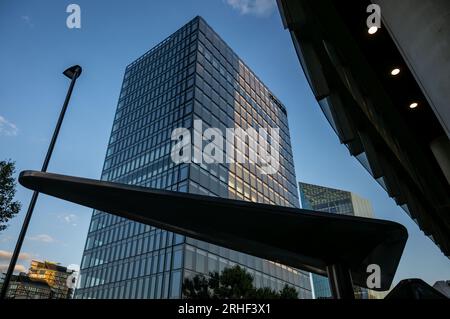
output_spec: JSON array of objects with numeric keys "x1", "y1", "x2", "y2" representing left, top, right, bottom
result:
[{"x1": 19, "y1": 171, "x2": 408, "y2": 290}]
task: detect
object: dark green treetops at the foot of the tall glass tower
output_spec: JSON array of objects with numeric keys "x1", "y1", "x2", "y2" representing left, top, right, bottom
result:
[{"x1": 183, "y1": 266, "x2": 298, "y2": 299}]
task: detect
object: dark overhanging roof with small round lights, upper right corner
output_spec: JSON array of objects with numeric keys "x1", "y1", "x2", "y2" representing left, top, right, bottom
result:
[{"x1": 278, "y1": 0, "x2": 450, "y2": 256}]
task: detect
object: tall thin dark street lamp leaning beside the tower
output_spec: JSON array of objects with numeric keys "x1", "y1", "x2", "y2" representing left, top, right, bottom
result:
[{"x1": 0, "y1": 65, "x2": 82, "y2": 300}]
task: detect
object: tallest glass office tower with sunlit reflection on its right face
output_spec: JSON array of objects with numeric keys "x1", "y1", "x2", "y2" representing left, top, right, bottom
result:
[{"x1": 76, "y1": 17, "x2": 311, "y2": 298}]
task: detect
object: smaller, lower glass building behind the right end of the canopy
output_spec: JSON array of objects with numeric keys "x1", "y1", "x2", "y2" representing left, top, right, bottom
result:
[{"x1": 299, "y1": 183, "x2": 374, "y2": 299}]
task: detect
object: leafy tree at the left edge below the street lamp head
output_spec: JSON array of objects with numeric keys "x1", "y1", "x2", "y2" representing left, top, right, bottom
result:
[{"x1": 0, "y1": 161, "x2": 21, "y2": 231}]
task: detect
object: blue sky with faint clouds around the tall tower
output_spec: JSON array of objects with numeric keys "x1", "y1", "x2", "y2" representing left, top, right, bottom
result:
[{"x1": 0, "y1": 0, "x2": 450, "y2": 284}]
